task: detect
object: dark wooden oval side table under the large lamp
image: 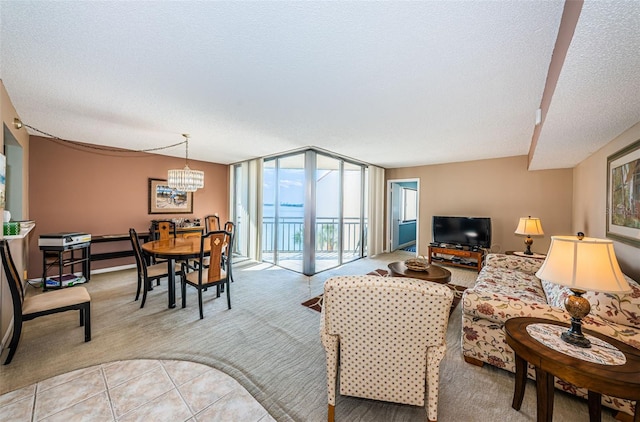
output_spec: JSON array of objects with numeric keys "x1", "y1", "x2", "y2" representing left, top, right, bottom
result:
[{"x1": 504, "y1": 318, "x2": 640, "y2": 422}]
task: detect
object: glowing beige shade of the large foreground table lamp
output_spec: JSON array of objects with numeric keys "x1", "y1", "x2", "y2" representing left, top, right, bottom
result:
[{"x1": 536, "y1": 236, "x2": 631, "y2": 292}]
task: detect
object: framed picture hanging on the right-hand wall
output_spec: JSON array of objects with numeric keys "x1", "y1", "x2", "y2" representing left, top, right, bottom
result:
[{"x1": 607, "y1": 140, "x2": 640, "y2": 247}]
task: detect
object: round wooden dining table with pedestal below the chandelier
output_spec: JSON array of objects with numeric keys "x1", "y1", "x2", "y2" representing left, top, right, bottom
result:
[{"x1": 142, "y1": 237, "x2": 211, "y2": 308}]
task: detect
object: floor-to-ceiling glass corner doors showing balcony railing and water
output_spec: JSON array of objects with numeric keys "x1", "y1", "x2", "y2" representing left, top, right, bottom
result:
[{"x1": 262, "y1": 150, "x2": 366, "y2": 275}]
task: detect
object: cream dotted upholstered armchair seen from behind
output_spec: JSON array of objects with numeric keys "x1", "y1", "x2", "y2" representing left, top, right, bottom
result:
[{"x1": 320, "y1": 276, "x2": 453, "y2": 421}]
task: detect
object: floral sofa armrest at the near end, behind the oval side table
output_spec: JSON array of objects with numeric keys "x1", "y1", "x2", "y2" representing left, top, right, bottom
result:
[{"x1": 462, "y1": 288, "x2": 571, "y2": 325}]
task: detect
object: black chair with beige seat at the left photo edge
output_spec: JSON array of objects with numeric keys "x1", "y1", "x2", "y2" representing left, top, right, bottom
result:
[{"x1": 0, "y1": 240, "x2": 91, "y2": 365}]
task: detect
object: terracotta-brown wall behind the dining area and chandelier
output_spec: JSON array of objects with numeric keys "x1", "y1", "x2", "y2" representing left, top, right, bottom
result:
[{"x1": 28, "y1": 136, "x2": 229, "y2": 278}]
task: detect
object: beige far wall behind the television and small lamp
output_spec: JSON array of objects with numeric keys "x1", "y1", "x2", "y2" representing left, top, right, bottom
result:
[{"x1": 385, "y1": 156, "x2": 573, "y2": 255}]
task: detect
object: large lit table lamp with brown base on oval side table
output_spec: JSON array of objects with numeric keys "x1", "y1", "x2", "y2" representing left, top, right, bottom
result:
[{"x1": 536, "y1": 233, "x2": 631, "y2": 347}]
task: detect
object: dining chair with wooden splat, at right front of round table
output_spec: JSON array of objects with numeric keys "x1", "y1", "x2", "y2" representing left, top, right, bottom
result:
[{"x1": 181, "y1": 230, "x2": 233, "y2": 319}]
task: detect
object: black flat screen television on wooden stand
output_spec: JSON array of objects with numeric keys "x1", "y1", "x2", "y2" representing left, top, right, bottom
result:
[{"x1": 432, "y1": 215, "x2": 491, "y2": 248}]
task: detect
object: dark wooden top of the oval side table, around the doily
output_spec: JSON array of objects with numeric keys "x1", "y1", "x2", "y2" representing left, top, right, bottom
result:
[{"x1": 504, "y1": 317, "x2": 640, "y2": 400}]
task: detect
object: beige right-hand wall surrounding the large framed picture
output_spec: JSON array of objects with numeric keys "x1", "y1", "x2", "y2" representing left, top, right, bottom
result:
[{"x1": 573, "y1": 123, "x2": 640, "y2": 280}]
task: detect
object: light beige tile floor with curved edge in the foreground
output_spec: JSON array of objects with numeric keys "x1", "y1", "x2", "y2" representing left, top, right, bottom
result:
[{"x1": 0, "y1": 360, "x2": 274, "y2": 422}]
